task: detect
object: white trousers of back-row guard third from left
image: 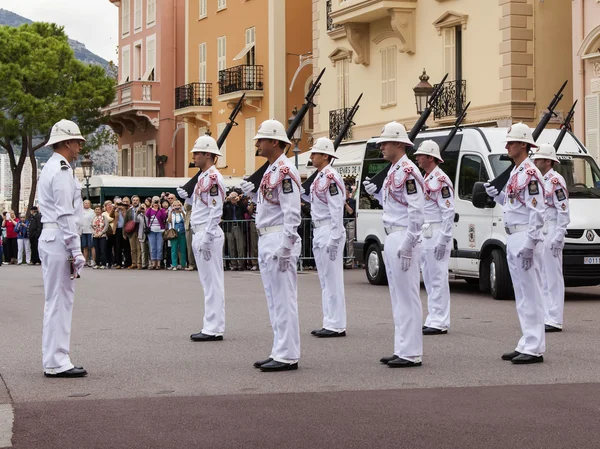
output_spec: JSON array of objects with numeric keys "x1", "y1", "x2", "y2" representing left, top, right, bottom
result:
[{"x1": 421, "y1": 229, "x2": 450, "y2": 330}]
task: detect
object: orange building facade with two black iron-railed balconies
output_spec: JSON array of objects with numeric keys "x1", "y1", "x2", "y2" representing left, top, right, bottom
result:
[{"x1": 175, "y1": 0, "x2": 312, "y2": 177}]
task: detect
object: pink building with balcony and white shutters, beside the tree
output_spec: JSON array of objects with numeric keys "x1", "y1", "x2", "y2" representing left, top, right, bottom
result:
[{"x1": 105, "y1": 0, "x2": 187, "y2": 177}]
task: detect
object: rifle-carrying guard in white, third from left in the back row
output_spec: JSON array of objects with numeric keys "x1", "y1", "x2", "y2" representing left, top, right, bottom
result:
[{"x1": 415, "y1": 140, "x2": 454, "y2": 335}]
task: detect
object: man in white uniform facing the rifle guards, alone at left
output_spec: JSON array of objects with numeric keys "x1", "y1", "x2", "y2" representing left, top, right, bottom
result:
[{"x1": 38, "y1": 120, "x2": 87, "y2": 377}]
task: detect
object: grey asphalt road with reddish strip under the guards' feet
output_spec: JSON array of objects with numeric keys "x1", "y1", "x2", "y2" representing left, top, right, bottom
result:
[{"x1": 0, "y1": 266, "x2": 600, "y2": 449}]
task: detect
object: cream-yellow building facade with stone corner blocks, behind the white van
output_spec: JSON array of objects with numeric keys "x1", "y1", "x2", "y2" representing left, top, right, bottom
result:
[{"x1": 312, "y1": 0, "x2": 572, "y2": 140}]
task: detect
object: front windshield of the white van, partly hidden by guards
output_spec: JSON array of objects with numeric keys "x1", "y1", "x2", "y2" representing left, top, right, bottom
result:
[{"x1": 490, "y1": 154, "x2": 600, "y2": 198}]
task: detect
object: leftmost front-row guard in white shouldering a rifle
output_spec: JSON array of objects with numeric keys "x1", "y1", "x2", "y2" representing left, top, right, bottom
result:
[{"x1": 241, "y1": 120, "x2": 301, "y2": 371}]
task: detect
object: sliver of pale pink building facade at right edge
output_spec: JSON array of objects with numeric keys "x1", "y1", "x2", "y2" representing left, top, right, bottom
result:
[{"x1": 572, "y1": 0, "x2": 600, "y2": 161}]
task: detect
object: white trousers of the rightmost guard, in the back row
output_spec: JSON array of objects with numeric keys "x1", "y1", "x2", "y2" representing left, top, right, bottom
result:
[{"x1": 542, "y1": 226, "x2": 565, "y2": 329}]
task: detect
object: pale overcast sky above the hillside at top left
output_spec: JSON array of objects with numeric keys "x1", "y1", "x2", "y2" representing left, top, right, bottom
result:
[{"x1": 0, "y1": 0, "x2": 119, "y2": 61}]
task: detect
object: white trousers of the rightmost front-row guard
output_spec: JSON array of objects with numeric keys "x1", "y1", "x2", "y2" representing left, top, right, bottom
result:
[{"x1": 506, "y1": 232, "x2": 546, "y2": 356}]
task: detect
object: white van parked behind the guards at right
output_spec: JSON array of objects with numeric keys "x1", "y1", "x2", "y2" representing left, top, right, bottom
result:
[{"x1": 352, "y1": 127, "x2": 600, "y2": 299}]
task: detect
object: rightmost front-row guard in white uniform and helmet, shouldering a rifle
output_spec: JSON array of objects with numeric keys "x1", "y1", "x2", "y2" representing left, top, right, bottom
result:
[{"x1": 485, "y1": 123, "x2": 546, "y2": 364}]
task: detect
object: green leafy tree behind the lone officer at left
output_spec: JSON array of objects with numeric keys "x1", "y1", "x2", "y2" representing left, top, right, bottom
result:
[{"x1": 0, "y1": 22, "x2": 115, "y2": 210}]
